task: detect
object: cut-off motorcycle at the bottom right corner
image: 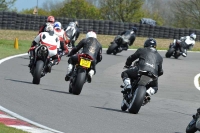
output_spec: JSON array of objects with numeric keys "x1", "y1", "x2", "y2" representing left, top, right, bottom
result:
[{"x1": 186, "y1": 108, "x2": 200, "y2": 133}]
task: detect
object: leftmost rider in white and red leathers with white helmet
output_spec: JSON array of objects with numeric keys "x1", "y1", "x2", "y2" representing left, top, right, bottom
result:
[{"x1": 28, "y1": 24, "x2": 60, "y2": 72}]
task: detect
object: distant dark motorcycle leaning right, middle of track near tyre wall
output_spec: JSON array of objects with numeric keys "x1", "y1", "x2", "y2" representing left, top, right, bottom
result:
[{"x1": 106, "y1": 31, "x2": 131, "y2": 55}]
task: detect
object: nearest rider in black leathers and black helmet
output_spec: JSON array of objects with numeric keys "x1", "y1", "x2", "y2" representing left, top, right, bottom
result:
[{"x1": 121, "y1": 38, "x2": 163, "y2": 102}]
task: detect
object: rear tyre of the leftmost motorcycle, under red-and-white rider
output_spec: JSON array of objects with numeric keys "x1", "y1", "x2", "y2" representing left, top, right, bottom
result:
[{"x1": 32, "y1": 60, "x2": 44, "y2": 84}]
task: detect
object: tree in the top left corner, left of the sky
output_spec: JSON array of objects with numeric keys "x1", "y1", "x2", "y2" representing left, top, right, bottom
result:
[{"x1": 0, "y1": 0, "x2": 16, "y2": 11}]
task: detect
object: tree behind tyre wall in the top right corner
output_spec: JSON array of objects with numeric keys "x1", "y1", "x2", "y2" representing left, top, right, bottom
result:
[{"x1": 173, "y1": 0, "x2": 200, "y2": 29}]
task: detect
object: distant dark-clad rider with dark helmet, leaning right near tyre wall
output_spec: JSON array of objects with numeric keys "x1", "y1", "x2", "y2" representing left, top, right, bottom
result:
[{"x1": 116, "y1": 27, "x2": 137, "y2": 51}]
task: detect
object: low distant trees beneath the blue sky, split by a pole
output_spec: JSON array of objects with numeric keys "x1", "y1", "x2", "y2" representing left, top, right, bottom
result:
[{"x1": 19, "y1": 8, "x2": 51, "y2": 16}]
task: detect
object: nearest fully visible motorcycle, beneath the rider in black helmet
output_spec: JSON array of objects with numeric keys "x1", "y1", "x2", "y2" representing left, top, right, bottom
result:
[{"x1": 121, "y1": 64, "x2": 157, "y2": 114}]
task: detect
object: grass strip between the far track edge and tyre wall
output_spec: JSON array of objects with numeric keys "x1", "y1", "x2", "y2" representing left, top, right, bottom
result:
[{"x1": 0, "y1": 30, "x2": 200, "y2": 59}]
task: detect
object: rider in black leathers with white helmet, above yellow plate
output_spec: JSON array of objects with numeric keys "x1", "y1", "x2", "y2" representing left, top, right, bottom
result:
[{"x1": 65, "y1": 31, "x2": 102, "y2": 83}]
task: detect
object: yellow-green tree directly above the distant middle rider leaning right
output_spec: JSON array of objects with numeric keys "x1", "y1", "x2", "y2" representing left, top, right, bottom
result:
[{"x1": 100, "y1": 0, "x2": 144, "y2": 22}]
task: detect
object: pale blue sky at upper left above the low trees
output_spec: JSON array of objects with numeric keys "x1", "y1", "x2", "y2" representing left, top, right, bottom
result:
[{"x1": 13, "y1": 0, "x2": 63, "y2": 11}]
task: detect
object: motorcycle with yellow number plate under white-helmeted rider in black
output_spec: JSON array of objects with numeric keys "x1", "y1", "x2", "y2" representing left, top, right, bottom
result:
[{"x1": 69, "y1": 53, "x2": 93, "y2": 95}]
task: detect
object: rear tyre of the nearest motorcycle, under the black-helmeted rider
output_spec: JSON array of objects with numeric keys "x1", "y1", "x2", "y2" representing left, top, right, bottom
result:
[{"x1": 128, "y1": 86, "x2": 146, "y2": 114}]
